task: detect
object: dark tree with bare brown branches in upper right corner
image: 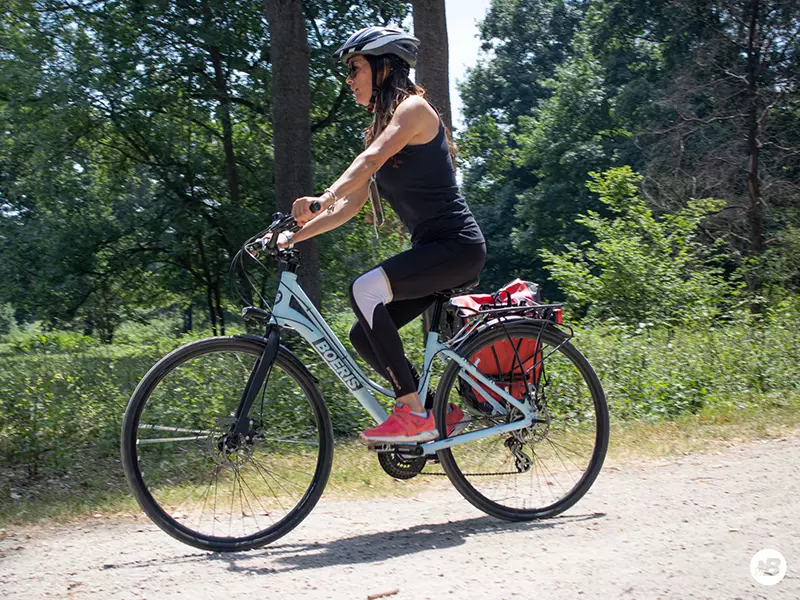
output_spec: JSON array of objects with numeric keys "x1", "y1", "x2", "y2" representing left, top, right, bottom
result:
[{"x1": 587, "y1": 0, "x2": 800, "y2": 291}]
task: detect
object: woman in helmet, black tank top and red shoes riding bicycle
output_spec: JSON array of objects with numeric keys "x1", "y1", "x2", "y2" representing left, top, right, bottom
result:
[{"x1": 268, "y1": 27, "x2": 486, "y2": 443}]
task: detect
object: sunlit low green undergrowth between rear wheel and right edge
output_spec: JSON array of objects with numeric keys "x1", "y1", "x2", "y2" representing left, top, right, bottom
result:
[{"x1": 576, "y1": 303, "x2": 800, "y2": 421}]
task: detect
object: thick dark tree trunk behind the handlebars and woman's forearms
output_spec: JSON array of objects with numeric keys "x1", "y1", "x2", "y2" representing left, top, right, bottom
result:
[{"x1": 264, "y1": 0, "x2": 321, "y2": 306}]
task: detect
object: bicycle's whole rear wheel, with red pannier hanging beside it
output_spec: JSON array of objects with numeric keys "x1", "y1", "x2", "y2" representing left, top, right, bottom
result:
[{"x1": 434, "y1": 320, "x2": 609, "y2": 521}]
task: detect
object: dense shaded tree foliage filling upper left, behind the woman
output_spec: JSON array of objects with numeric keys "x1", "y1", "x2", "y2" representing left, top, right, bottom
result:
[{"x1": 0, "y1": 0, "x2": 408, "y2": 342}]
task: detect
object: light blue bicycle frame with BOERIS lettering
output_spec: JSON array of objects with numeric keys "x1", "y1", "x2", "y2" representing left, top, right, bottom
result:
[{"x1": 270, "y1": 271, "x2": 537, "y2": 455}]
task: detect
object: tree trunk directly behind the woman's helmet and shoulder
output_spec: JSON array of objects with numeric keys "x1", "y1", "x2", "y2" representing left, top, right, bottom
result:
[{"x1": 411, "y1": 0, "x2": 452, "y2": 130}]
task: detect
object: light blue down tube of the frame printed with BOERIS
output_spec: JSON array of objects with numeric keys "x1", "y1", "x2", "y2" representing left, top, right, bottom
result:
[{"x1": 272, "y1": 271, "x2": 394, "y2": 423}]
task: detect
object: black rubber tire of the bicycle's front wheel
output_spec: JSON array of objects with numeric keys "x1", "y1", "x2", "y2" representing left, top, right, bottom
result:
[{"x1": 120, "y1": 337, "x2": 333, "y2": 552}]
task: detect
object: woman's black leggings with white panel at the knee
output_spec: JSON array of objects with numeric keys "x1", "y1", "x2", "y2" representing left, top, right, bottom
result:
[{"x1": 350, "y1": 240, "x2": 486, "y2": 397}]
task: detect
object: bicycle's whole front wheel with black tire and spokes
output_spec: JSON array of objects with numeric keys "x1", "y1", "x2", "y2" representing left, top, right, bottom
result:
[{"x1": 121, "y1": 337, "x2": 333, "y2": 551}]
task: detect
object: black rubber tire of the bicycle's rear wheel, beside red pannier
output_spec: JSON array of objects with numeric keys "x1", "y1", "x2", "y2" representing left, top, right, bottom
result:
[{"x1": 434, "y1": 320, "x2": 610, "y2": 521}]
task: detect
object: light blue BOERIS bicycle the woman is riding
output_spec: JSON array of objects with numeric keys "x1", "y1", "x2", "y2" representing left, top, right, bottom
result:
[{"x1": 121, "y1": 214, "x2": 609, "y2": 551}]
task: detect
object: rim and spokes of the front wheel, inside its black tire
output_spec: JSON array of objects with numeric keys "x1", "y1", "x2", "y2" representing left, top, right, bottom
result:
[{"x1": 130, "y1": 348, "x2": 322, "y2": 542}]
